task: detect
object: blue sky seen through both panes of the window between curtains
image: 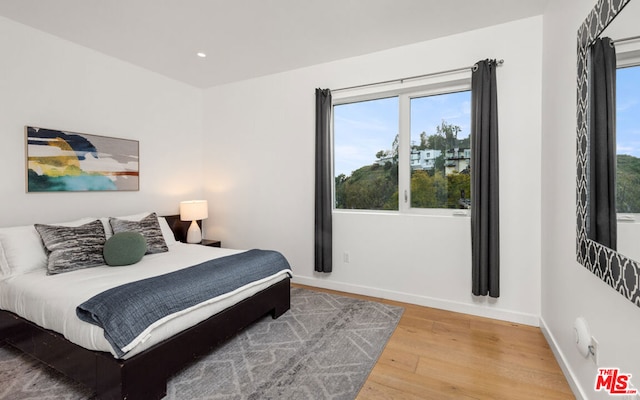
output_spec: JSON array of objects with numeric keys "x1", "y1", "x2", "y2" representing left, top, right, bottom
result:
[{"x1": 333, "y1": 91, "x2": 471, "y2": 176}]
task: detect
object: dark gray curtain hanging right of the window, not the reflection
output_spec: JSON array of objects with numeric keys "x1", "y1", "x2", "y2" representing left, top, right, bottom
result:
[{"x1": 471, "y1": 60, "x2": 500, "y2": 297}]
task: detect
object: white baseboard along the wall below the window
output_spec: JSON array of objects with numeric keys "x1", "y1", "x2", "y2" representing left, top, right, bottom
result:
[{"x1": 292, "y1": 276, "x2": 540, "y2": 326}]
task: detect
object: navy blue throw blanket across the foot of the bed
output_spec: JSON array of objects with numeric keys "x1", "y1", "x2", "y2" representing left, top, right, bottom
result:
[{"x1": 76, "y1": 249, "x2": 291, "y2": 357}]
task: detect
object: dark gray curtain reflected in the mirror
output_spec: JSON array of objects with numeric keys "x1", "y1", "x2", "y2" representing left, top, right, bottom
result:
[{"x1": 588, "y1": 38, "x2": 617, "y2": 250}]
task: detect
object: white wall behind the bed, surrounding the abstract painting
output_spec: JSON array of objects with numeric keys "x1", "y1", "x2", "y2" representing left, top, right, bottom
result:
[{"x1": 0, "y1": 18, "x2": 203, "y2": 226}]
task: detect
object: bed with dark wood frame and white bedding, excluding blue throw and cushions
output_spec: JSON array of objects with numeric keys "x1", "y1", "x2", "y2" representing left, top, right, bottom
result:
[{"x1": 0, "y1": 213, "x2": 291, "y2": 399}]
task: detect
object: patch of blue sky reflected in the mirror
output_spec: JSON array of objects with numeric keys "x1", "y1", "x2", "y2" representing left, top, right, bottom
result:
[{"x1": 616, "y1": 66, "x2": 640, "y2": 157}]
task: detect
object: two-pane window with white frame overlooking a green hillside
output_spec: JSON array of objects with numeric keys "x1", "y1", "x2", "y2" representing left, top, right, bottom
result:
[{"x1": 333, "y1": 79, "x2": 471, "y2": 211}]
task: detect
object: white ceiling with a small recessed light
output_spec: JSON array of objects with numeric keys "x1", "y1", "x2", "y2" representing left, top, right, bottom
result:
[{"x1": 0, "y1": 0, "x2": 550, "y2": 88}]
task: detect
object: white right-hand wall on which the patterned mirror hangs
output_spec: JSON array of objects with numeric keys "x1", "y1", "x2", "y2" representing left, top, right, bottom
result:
[{"x1": 542, "y1": 0, "x2": 640, "y2": 399}]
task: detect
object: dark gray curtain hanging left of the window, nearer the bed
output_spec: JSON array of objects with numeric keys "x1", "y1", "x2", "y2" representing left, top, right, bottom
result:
[{"x1": 315, "y1": 89, "x2": 333, "y2": 272}]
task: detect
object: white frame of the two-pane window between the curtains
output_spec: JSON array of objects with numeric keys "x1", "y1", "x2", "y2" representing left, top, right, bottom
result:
[{"x1": 331, "y1": 70, "x2": 473, "y2": 217}]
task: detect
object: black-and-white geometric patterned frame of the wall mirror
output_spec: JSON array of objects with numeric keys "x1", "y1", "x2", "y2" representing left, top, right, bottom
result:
[{"x1": 576, "y1": 0, "x2": 640, "y2": 307}]
